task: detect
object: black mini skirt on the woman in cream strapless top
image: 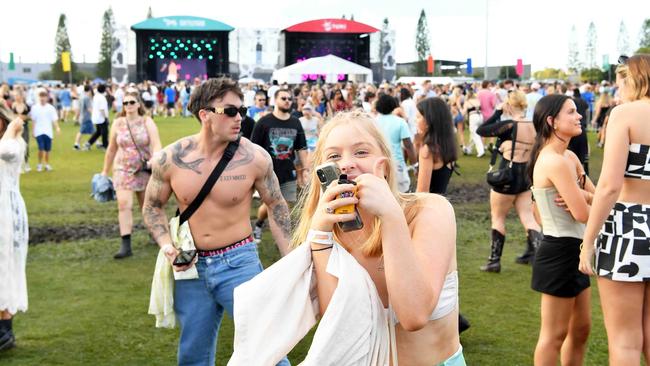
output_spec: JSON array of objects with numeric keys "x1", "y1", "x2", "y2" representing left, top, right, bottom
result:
[{"x1": 531, "y1": 235, "x2": 590, "y2": 297}]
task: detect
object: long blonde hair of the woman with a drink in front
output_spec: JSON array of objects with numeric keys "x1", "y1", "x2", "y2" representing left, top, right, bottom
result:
[{"x1": 291, "y1": 111, "x2": 420, "y2": 257}]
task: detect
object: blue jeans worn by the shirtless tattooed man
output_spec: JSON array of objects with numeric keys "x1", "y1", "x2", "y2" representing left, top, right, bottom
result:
[{"x1": 174, "y1": 243, "x2": 290, "y2": 366}]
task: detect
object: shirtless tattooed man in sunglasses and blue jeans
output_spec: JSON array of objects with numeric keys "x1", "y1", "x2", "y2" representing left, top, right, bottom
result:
[{"x1": 143, "y1": 78, "x2": 291, "y2": 365}]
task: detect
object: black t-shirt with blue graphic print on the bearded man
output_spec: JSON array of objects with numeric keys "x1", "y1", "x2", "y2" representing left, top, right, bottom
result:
[{"x1": 251, "y1": 114, "x2": 307, "y2": 184}]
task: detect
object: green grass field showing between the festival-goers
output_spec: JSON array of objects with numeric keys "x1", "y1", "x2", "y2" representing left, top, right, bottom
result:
[{"x1": 0, "y1": 113, "x2": 607, "y2": 365}]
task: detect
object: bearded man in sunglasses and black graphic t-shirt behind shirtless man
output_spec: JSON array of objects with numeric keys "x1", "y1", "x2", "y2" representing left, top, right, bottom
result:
[{"x1": 251, "y1": 89, "x2": 308, "y2": 242}]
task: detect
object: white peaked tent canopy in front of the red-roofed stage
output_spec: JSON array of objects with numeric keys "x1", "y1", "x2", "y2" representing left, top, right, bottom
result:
[{"x1": 273, "y1": 55, "x2": 372, "y2": 84}]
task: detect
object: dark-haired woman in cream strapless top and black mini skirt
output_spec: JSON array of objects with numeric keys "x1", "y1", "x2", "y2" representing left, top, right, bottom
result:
[{"x1": 528, "y1": 94, "x2": 594, "y2": 365}]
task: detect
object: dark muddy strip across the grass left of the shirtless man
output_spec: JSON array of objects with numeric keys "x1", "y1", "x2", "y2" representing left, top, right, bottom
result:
[{"x1": 29, "y1": 224, "x2": 144, "y2": 245}]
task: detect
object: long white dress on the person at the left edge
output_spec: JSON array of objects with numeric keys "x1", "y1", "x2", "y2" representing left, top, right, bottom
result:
[{"x1": 0, "y1": 136, "x2": 29, "y2": 314}]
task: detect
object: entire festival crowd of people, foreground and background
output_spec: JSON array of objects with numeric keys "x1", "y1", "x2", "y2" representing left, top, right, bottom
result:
[{"x1": 0, "y1": 55, "x2": 650, "y2": 365}]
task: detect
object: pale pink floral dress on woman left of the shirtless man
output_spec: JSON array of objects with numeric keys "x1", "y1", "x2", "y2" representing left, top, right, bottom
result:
[{"x1": 113, "y1": 117, "x2": 151, "y2": 192}]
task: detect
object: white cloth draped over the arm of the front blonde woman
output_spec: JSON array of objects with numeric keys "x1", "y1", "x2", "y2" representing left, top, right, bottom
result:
[{"x1": 228, "y1": 243, "x2": 390, "y2": 366}]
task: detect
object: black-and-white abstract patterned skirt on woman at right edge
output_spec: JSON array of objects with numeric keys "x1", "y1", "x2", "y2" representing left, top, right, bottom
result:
[{"x1": 596, "y1": 202, "x2": 650, "y2": 282}]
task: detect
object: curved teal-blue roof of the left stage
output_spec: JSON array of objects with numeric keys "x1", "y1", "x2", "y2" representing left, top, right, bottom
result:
[{"x1": 131, "y1": 15, "x2": 235, "y2": 32}]
